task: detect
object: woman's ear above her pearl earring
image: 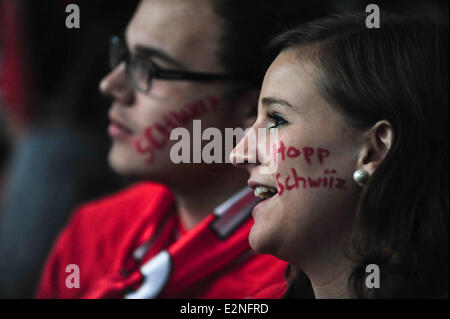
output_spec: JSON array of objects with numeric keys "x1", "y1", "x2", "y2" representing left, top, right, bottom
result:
[{"x1": 358, "y1": 120, "x2": 394, "y2": 176}]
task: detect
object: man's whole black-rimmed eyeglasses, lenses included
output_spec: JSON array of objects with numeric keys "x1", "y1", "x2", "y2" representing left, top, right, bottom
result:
[{"x1": 109, "y1": 36, "x2": 242, "y2": 93}]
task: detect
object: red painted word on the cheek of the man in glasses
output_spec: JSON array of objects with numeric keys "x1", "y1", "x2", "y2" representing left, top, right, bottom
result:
[{"x1": 133, "y1": 96, "x2": 220, "y2": 164}]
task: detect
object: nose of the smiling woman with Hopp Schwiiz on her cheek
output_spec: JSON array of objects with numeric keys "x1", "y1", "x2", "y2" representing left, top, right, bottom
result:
[{"x1": 230, "y1": 127, "x2": 259, "y2": 167}]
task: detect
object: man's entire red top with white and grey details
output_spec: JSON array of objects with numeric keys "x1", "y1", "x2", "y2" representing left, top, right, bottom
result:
[{"x1": 37, "y1": 183, "x2": 287, "y2": 298}]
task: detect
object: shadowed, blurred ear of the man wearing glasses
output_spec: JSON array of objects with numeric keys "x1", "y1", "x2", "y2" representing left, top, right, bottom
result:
[{"x1": 233, "y1": 89, "x2": 259, "y2": 129}]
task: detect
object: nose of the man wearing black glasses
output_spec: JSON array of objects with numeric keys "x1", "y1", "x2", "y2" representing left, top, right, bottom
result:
[{"x1": 100, "y1": 63, "x2": 134, "y2": 105}]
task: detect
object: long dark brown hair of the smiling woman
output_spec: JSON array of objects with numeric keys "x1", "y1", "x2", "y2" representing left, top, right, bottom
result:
[{"x1": 271, "y1": 12, "x2": 449, "y2": 298}]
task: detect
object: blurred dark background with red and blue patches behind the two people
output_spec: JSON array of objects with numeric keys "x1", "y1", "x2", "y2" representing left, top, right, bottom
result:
[{"x1": 0, "y1": 0, "x2": 448, "y2": 298}]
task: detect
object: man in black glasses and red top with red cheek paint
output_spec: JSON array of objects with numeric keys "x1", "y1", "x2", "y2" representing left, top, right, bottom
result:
[{"x1": 37, "y1": 0, "x2": 330, "y2": 298}]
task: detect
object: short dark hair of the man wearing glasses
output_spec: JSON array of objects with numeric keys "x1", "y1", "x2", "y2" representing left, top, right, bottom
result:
[{"x1": 211, "y1": 0, "x2": 331, "y2": 95}]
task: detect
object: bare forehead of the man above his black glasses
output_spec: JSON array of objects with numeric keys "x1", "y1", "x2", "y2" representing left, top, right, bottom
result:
[{"x1": 126, "y1": 0, "x2": 221, "y2": 69}]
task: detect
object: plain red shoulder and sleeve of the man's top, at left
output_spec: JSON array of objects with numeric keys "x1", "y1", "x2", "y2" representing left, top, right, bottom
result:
[{"x1": 36, "y1": 183, "x2": 173, "y2": 299}]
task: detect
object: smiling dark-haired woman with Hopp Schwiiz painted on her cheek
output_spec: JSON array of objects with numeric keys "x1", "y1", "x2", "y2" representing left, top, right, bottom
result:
[{"x1": 231, "y1": 13, "x2": 449, "y2": 298}]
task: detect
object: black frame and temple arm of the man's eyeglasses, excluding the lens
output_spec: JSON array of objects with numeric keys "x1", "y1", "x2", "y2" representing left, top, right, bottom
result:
[{"x1": 109, "y1": 36, "x2": 247, "y2": 93}]
